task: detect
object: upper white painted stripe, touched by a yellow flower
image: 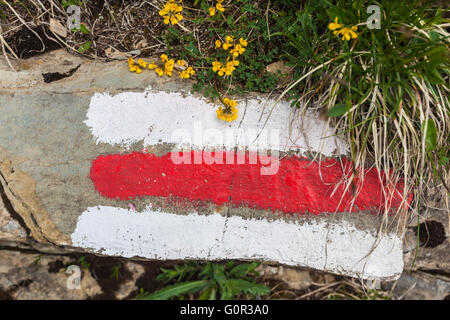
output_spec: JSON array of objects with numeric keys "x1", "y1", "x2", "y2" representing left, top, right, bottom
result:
[{"x1": 85, "y1": 89, "x2": 348, "y2": 156}]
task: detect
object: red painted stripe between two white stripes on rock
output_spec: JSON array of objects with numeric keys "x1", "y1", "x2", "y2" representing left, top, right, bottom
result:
[{"x1": 90, "y1": 151, "x2": 411, "y2": 214}]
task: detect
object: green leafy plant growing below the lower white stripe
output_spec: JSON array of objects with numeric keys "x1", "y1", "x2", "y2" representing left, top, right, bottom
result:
[{"x1": 137, "y1": 261, "x2": 270, "y2": 300}]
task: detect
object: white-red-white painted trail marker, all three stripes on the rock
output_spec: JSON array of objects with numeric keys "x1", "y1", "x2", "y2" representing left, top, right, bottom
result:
[{"x1": 72, "y1": 90, "x2": 403, "y2": 278}]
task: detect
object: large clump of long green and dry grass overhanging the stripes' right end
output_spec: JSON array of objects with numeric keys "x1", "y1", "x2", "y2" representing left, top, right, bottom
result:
[{"x1": 271, "y1": 0, "x2": 450, "y2": 223}]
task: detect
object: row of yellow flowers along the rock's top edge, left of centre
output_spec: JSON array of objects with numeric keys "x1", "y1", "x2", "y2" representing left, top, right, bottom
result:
[{"x1": 128, "y1": 54, "x2": 195, "y2": 79}]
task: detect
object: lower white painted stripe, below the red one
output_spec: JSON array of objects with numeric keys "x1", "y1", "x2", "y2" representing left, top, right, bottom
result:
[{"x1": 72, "y1": 206, "x2": 403, "y2": 279}]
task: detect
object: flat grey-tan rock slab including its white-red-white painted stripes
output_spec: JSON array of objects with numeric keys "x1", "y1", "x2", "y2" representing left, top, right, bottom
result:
[{"x1": 0, "y1": 55, "x2": 403, "y2": 279}]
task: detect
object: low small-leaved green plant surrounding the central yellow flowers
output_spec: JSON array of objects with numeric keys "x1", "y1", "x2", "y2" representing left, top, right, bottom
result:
[{"x1": 155, "y1": 0, "x2": 290, "y2": 98}]
